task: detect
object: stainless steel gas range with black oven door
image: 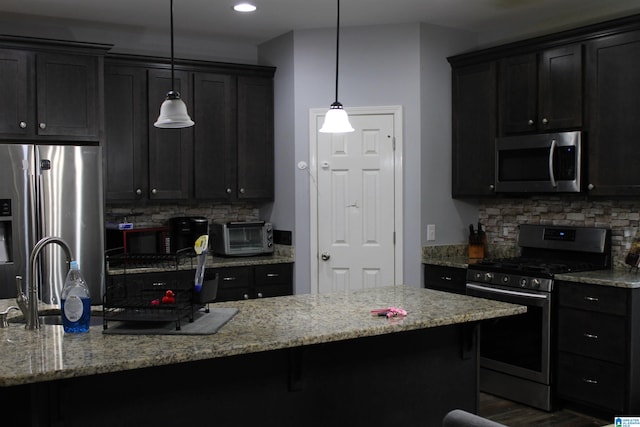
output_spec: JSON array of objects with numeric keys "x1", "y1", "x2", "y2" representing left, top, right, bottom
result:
[{"x1": 466, "y1": 225, "x2": 611, "y2": 411}]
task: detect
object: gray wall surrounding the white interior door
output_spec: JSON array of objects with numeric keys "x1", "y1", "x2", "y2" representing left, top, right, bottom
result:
[{"x1": 259, "y1": 24, "x2": 477, "y2": 293}]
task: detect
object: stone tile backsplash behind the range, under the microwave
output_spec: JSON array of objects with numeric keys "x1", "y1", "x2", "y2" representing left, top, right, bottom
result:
[{"x1": 478, "y1": 195, "x2": 640, "y2": 266}]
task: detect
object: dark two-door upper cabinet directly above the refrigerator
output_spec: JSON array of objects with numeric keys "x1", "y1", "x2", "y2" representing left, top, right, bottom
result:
[{"x1": 0, "y1": 38, "x2": 106, "y2": 142}]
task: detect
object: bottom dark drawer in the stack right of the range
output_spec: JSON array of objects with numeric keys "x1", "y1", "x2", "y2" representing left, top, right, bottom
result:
[{"x1": 557, "y1": 352, "x2": 626, "y2": 413}]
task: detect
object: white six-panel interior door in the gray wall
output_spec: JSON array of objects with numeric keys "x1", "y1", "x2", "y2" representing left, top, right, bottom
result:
[{"x1": 312, "y1": 107, "x2": 398, "y2": 292}]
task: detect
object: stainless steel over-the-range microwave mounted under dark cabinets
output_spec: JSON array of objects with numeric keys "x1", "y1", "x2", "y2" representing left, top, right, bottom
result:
[{"x1": 495, "y1": 131, "x2": 582, "y2": 193}]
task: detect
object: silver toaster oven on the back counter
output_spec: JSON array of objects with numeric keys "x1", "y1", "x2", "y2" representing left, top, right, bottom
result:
[{"x1": 210, "y1": 221, "x2": 273, "y2": 256}]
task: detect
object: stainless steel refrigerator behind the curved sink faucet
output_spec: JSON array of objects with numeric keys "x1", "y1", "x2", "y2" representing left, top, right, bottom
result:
[{"x1": 0, "y1": 144, "x2": 104, "y2": 305}]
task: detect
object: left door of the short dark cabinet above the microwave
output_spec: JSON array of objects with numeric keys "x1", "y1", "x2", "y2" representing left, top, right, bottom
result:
[{"x1": 499, "y1": 53, "x2": 538, "y2": 134}]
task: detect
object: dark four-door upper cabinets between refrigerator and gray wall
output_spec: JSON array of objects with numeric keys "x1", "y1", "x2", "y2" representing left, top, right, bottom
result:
[{"x1": 105, "y1": 55, "x2": 275, "y2": 202}]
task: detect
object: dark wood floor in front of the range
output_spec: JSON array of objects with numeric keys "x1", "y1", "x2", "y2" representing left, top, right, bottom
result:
[{"x1": 478, "y1": 393, "x2": 613, "y2": 427}]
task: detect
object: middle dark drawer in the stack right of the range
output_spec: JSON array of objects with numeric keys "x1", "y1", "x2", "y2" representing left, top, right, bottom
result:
[{"x1": 558, "y1": 308, "x2": 627, "y2": 363}]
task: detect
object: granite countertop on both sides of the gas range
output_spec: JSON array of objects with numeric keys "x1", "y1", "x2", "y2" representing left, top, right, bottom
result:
[{"x1": 422, "y1": 256, "x2": 640, "y2": 289}]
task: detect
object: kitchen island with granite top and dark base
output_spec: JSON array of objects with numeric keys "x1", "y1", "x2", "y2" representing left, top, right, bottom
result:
[{"x1": 0, "y1": 286, "x2": 526, "y2": 426}]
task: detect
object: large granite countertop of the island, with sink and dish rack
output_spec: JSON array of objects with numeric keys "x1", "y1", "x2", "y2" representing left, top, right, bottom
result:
[{"x1": 0, "y1": 285, "x2": 526, "y2": 387}]
